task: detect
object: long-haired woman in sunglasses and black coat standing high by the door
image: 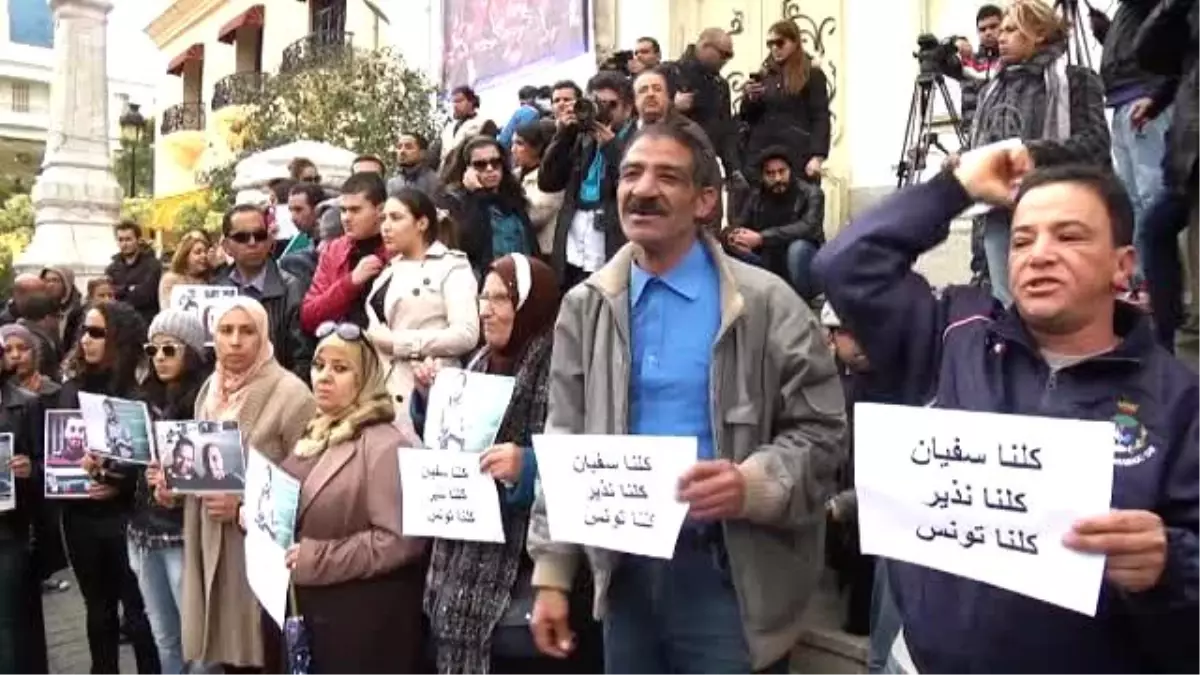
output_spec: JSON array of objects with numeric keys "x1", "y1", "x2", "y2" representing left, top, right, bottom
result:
[{"x1": 740, "y1": 20, "x2": 832, "y2": 184}]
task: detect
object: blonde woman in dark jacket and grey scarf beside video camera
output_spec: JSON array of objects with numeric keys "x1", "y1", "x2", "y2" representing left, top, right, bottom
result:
[{"x1": 971, "y1": 0, "x2": 1112, "y2": 305}]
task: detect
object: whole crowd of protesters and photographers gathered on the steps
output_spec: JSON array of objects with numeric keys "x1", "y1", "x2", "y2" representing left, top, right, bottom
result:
[{"x1": 0, "y1": 0, "x2": 1200, "y2": 675}]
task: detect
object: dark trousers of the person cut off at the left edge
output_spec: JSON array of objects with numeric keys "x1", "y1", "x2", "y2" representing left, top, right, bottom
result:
[{"x1": 0, "y1": 532, "x2": 48, "y2": 675}]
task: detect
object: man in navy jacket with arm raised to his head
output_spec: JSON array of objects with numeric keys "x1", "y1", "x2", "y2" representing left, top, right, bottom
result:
[{"x1": 811, "y1": 142, "x2": 1200, "y2": 675}]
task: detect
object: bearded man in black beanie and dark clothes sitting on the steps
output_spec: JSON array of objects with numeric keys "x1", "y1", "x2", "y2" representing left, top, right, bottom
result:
[{"x1": 724, "y1": 145, "x2": 824, "y2": 303}]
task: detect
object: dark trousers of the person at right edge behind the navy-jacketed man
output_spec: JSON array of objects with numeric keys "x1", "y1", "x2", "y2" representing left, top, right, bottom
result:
[{"x1": 1141, "y1": 191, "x2": 1195, "y2": 345}]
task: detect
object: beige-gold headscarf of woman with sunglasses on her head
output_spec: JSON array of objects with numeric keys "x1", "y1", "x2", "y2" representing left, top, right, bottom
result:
[{"x1": 293, "y1": 331, "x2": 396, "y2": 458}]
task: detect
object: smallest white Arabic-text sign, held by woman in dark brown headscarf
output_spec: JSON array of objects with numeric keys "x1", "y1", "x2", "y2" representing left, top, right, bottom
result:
[{"x1": 397, "y1": 448, "x2": 504, "y2": 544}]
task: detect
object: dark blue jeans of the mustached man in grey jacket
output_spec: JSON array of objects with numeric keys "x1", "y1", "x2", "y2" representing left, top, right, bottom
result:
[{"x1": 604, "y1": 533, "x2": 787, "y2": 675}]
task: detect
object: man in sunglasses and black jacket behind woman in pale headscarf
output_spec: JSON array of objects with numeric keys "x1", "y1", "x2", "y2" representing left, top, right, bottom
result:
[{"x1": 212, "y1": 204, "x2": 313, "y2": 382}]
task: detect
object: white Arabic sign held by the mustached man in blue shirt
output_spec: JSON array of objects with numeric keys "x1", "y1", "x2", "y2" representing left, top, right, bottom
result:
[{"x1": 533, "y1": 435, "x2": 696, "y2": 558}]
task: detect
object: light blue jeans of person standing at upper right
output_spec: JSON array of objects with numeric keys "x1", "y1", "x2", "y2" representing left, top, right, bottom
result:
[{"x1": 1112, "y1": 102, "x2": 1171, "y2": 279}]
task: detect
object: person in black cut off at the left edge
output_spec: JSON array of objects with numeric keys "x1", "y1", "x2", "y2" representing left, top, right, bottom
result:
[{"x1": 0, "y1": 327, "x2": 51, "y2": 675}]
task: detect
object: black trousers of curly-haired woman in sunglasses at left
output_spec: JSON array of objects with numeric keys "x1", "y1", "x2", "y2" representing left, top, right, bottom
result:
[{"x1": 62, "y1": 509, "x2": 160, "y2": 675}]
